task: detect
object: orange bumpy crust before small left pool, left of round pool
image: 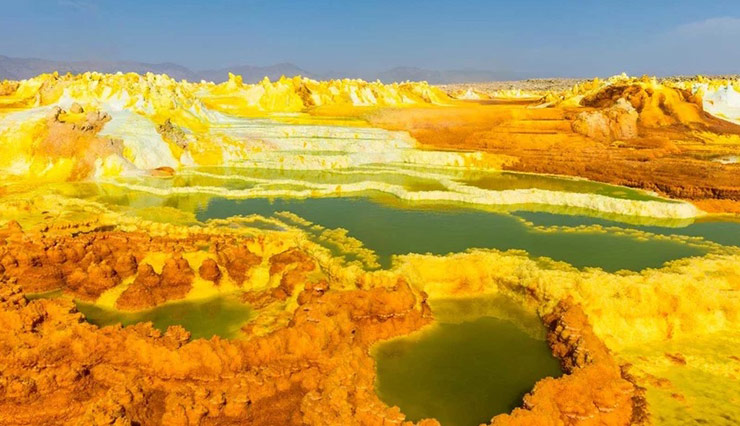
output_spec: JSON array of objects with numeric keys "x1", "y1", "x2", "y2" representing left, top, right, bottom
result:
[{"x1": 0, "y1": 251, "x2": 436, "y2": 425}]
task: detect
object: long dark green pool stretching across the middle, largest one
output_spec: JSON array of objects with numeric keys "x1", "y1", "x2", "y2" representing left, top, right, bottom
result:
[{"x1": 197, "y1": 198, "x2": 706, "y2": 271}]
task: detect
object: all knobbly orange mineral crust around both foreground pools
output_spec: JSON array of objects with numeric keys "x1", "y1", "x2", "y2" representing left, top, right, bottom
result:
[{"x1": 0, "y1": 223, "x2": 641, "y2": 425}]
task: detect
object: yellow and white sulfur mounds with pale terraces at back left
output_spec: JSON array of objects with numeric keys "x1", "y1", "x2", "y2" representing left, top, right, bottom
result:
[{"x1": 0, "y1": 73, "x2": 450, "y2": 180}]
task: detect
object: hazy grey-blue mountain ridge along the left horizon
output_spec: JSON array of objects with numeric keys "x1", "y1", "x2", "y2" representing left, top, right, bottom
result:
[{"x1": 0, "y1": 55, "x2": 529, "y2": 84}]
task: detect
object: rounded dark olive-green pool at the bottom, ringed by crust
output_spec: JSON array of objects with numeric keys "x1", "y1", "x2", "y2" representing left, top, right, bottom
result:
[{"x1": 373, "y1": 317, "x2": 562, "y2": 426}]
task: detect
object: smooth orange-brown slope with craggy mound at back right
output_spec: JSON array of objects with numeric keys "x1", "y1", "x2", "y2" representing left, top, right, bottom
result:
[{"x1": 368, "y1": 81, "x2": 740, "y2": 213}]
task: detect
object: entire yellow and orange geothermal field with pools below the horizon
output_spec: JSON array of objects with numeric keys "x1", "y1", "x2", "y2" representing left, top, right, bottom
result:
[{"x1": 0, "y1": 72, "x2": 740, "y2": 426}]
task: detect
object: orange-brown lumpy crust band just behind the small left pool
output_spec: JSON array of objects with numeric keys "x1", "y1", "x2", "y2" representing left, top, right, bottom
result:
[{"x1": 0, "y1": 222, "x2": 315, "y2": 310}]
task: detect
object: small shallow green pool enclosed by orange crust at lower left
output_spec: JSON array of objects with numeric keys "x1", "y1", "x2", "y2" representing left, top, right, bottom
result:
[{"x1": 75, "y1": 296, "x2": 254, "y2": 339}]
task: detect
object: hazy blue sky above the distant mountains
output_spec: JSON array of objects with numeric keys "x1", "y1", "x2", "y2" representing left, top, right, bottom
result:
[{"x1": 0, "y1": 0, "x2": 740, "y2": 77}]
